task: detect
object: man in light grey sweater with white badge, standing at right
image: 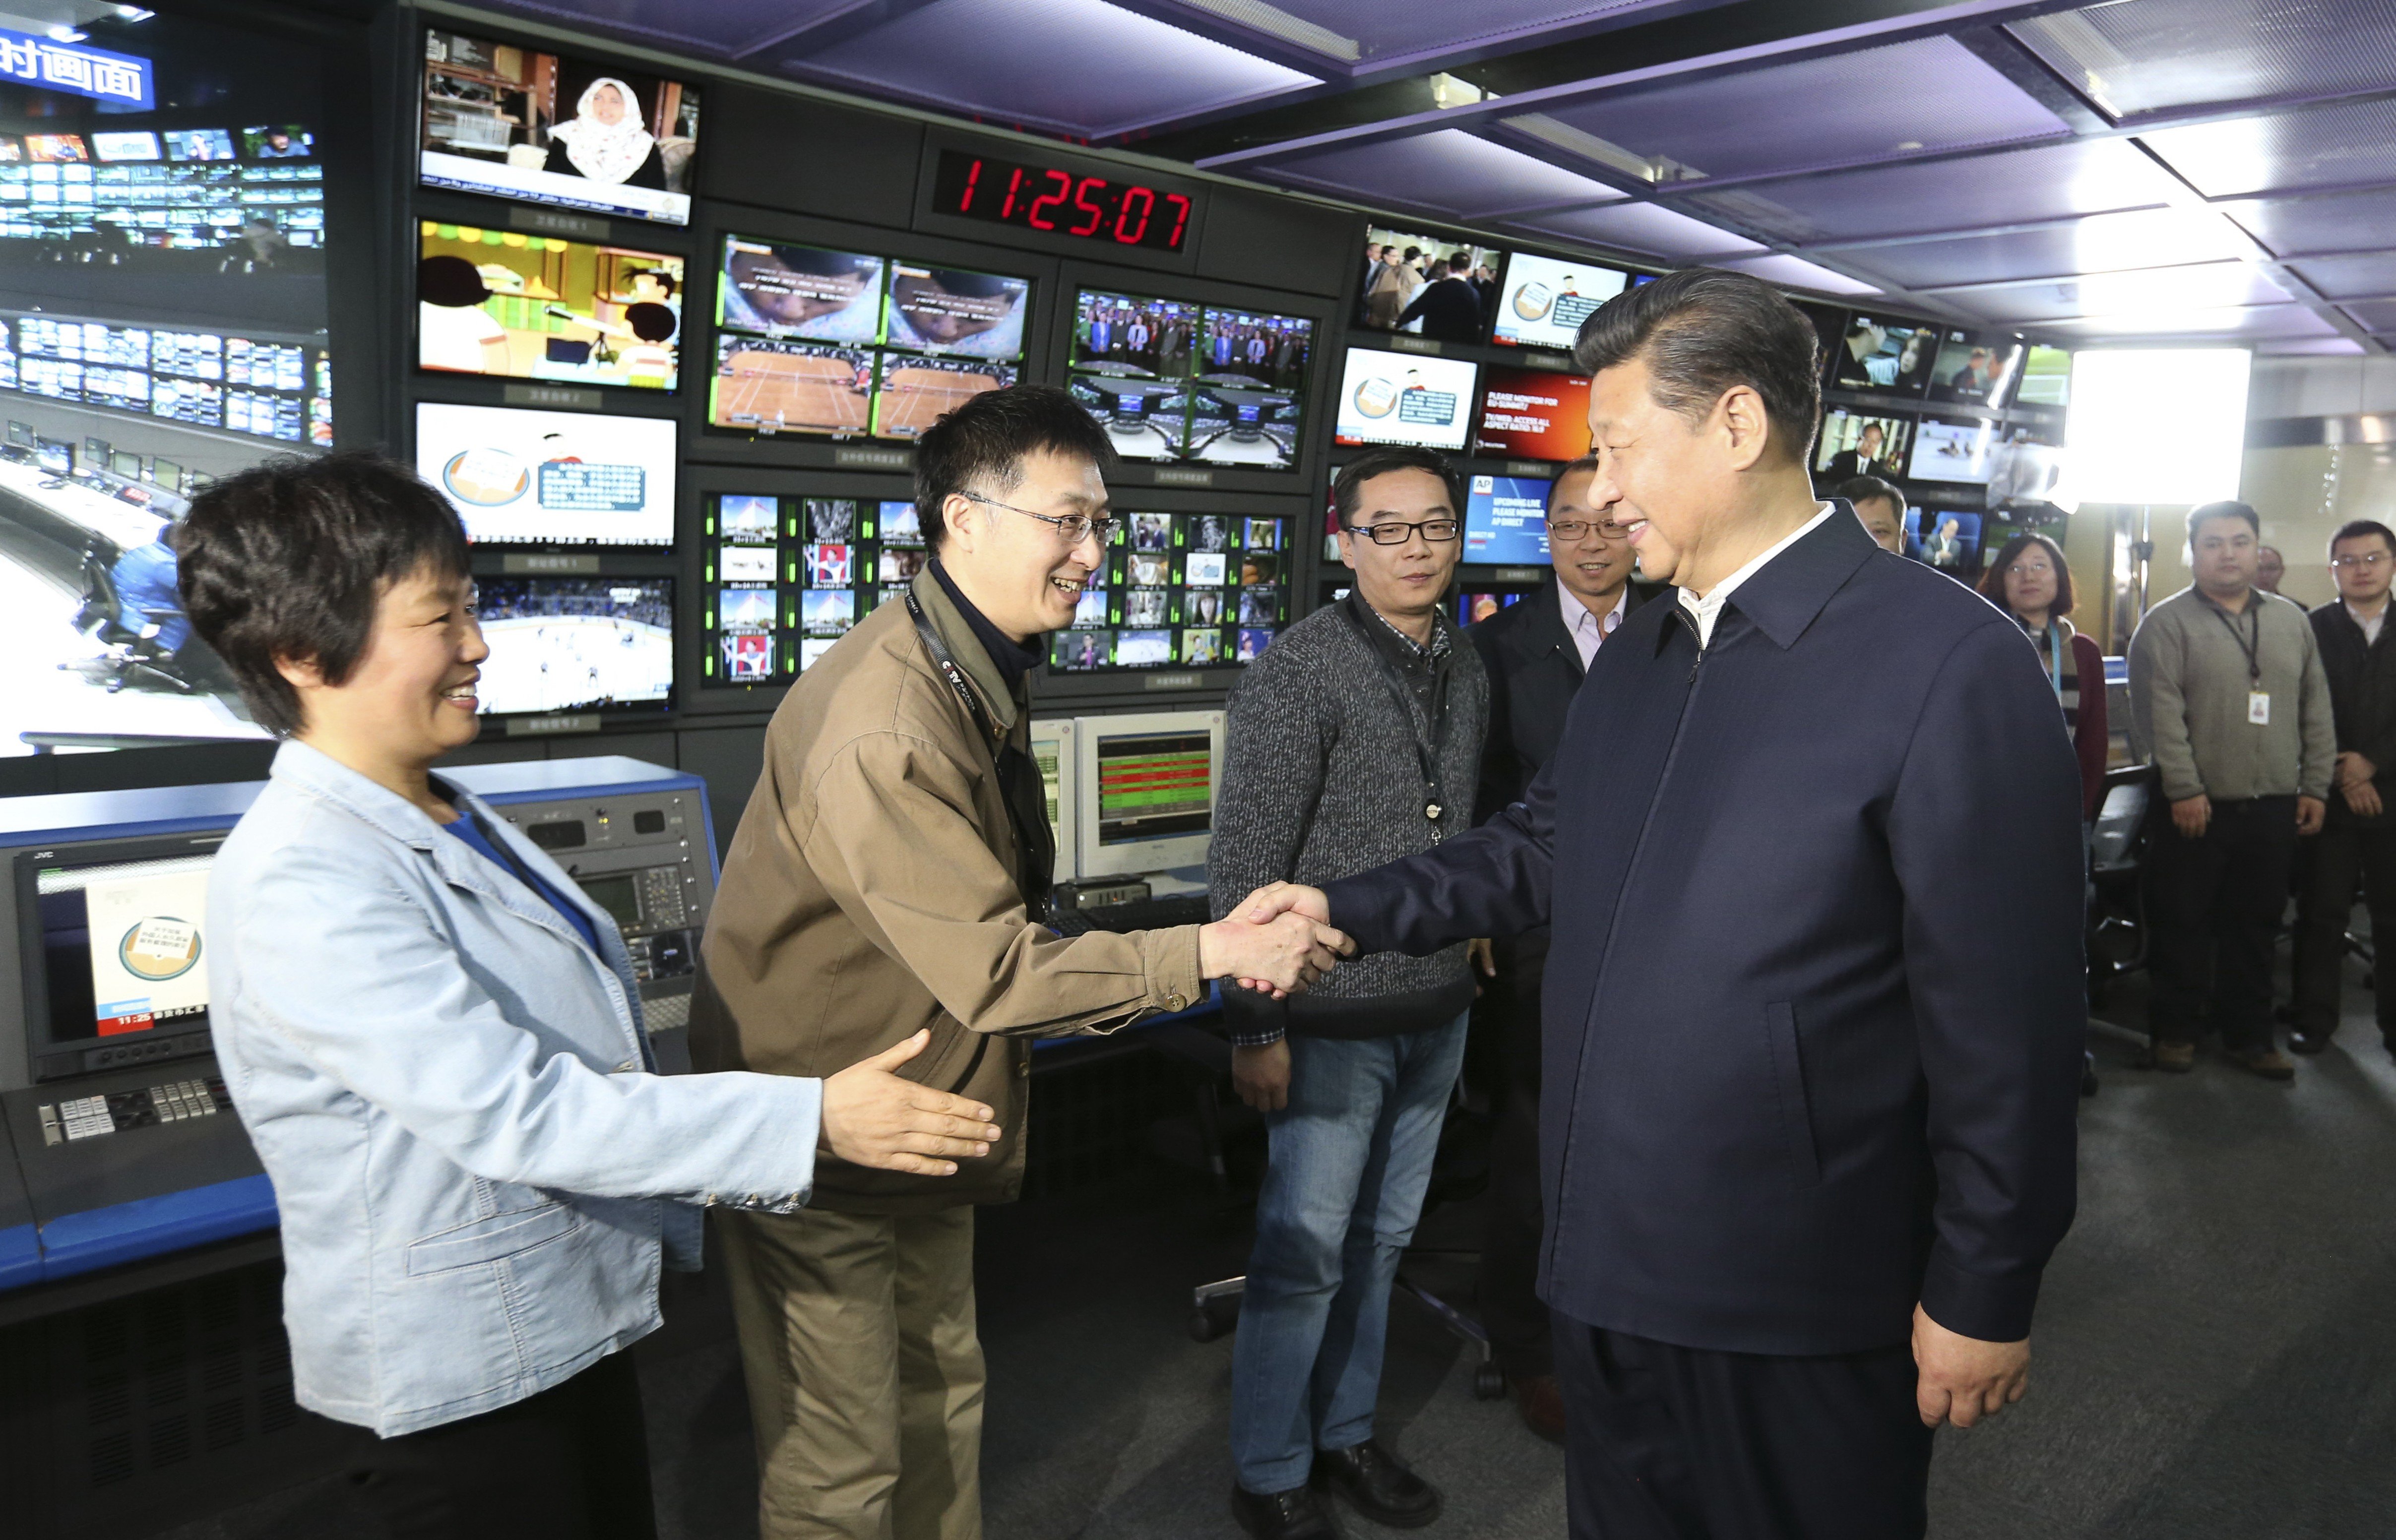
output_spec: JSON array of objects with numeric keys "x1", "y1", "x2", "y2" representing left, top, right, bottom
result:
[{"x1": 2130, "y1": 503, "x2": 2338, "y2": 1080}]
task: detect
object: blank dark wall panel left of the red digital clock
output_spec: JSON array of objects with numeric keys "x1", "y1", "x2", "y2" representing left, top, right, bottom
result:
[{"x1": 697, "y1": 86, "x2": 923, "y2": 230}]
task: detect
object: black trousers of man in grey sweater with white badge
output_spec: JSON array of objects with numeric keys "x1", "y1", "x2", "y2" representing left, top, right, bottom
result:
[{"x1": 2147, "y1": 798, "x2": 2295, "y2": 1054}]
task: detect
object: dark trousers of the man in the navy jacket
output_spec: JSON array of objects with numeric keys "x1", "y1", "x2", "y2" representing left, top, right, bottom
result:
[{"x1": 1555, "y1": 1315, "x2": 1931, "y2": 1540}]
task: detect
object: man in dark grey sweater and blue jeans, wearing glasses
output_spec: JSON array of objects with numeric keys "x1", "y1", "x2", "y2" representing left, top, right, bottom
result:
[{"x1": 1207, "y1": 450, "x2": 1488, "y2": 1540}]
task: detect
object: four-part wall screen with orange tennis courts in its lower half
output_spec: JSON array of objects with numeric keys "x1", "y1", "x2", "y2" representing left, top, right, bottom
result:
[{"x1": 707, "y1": 235, "x2": 1030, "y2": 438}]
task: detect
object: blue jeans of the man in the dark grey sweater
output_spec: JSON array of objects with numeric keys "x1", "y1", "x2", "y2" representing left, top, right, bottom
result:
[{"x1": 1232, "y1": 1015, "x2": 1466, "y2": 1492}]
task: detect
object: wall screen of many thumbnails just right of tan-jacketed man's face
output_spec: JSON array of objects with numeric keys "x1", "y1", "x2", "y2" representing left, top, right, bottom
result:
[{"x1": 1050, "y1": 512, "x2": 1289, "y2": 673}]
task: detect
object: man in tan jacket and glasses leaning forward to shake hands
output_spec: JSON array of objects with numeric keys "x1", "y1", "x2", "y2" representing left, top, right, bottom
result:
[{"x1": 690, "y1": 385, "x2": 1346, "y2": 1540}]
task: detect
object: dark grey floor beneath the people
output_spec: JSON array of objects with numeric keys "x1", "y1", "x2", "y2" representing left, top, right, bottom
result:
[{"x1": 170, "y1": 991, "x2": 2396, "y2": 1540}]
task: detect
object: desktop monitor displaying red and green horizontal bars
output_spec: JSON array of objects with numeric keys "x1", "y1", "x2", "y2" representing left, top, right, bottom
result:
[{"x1": 1073, "y1": 711, "x2": 1224, "y2": 879}]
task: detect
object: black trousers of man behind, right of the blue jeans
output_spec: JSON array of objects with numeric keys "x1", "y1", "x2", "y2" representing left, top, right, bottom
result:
[{"x1": 1473, "y1": 931, "x2": 1552, "y2": 1379}]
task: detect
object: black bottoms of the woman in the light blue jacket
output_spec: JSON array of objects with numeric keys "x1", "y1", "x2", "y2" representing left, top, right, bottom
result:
[{"x1": 335, "y1": 1353, "x2": 656, "y2": 1540}]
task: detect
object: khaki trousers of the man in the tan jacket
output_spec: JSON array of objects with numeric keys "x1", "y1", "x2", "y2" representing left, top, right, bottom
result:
[{"x1": 719, "y1": 1207, "x2": 982, "y2": 1540}]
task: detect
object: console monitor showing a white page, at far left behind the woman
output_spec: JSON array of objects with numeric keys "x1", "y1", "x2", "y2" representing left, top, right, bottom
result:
[{"x1": 12, "y1": 831, "x2": 225, "y2": 1080}]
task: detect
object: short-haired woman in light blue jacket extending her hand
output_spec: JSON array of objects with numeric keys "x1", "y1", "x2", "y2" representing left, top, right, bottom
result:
[{"x1": 177, "y1": 455, "x2": 999, "y2": 1538}]
